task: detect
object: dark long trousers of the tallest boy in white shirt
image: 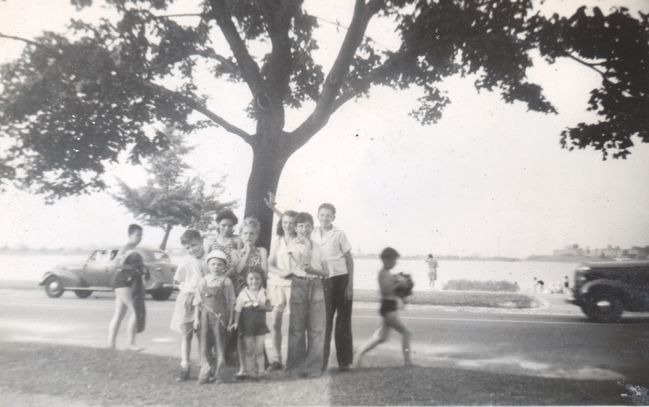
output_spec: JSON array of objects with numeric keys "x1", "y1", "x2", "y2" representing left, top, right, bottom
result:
[{"x1": 322, "y1": 274, "x2": 354, "y2": 370}]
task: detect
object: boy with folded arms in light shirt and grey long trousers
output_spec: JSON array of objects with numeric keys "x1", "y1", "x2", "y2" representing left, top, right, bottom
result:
[{"x1": 286, "y1": 212, "x2": 329, "y2": 377}]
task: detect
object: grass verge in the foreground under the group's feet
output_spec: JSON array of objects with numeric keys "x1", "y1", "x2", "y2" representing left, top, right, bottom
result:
[{"x1": 0, "y1": 343, "x2": 631, "y2": 406}]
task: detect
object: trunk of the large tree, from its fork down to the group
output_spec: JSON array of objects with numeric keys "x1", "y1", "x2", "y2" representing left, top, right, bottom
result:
[{"x1": 245, "y1": 135, "x2": 290, "y2": 249}]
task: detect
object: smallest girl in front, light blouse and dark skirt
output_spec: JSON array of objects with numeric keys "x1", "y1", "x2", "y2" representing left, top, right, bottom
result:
[{"x1": 231, "y1": 267, "x2": 273, "y2": 379}]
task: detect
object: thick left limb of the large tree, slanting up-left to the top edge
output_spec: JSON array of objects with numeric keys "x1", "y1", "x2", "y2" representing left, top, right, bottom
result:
[{"x1": 210, "y1": 0, "x2": 264, "y2": 96}]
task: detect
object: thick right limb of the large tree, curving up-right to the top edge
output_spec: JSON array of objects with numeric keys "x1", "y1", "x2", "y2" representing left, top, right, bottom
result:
[{"x1": 292, "y1": 0, "x2": 378, "y2": 149}]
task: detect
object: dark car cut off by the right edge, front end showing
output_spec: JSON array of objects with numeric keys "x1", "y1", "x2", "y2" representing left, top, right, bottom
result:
[{"x1": 568, "y1": 261, "x2": 649, "y2": 322}]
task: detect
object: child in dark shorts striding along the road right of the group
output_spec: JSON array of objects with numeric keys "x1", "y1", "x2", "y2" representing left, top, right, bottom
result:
[{"x1": 354, "y1": 247, "x2": 412, "y2": 367}]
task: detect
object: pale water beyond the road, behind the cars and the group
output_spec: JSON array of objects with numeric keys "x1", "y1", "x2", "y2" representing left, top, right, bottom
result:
[{"x1": 0, "y1": 254, "x2": 578, "y2": 291}]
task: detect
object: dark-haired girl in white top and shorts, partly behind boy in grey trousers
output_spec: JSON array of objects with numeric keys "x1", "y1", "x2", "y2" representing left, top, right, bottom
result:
[{"x1": 268, "y1": 211, "x2": 297, "y2": 370}]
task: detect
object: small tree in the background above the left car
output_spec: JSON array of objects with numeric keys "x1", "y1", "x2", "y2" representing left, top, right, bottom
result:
[{"x1": 112, "y1": 127, "x2": 236, "y2": 250}]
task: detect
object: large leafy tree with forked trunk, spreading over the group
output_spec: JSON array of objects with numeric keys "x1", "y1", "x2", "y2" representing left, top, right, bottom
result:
[{"x1": 0, "y1": 0, "x2": 649, "y2": 249}]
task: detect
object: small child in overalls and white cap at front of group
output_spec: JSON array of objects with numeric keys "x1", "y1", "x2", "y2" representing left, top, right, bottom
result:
[{"x1": 194, "y1": 250, "x2": 236, "y2": 384}]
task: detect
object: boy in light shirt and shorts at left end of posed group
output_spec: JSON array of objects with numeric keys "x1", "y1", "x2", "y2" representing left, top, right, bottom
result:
[{"x1": 170, "y1": 229, "x2": 207, "y2": 381}]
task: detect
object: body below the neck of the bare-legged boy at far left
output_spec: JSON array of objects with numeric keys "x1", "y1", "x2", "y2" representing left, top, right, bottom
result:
[{"x1": 108, "y1": 252, "x2": 145, "y2": 352}]
